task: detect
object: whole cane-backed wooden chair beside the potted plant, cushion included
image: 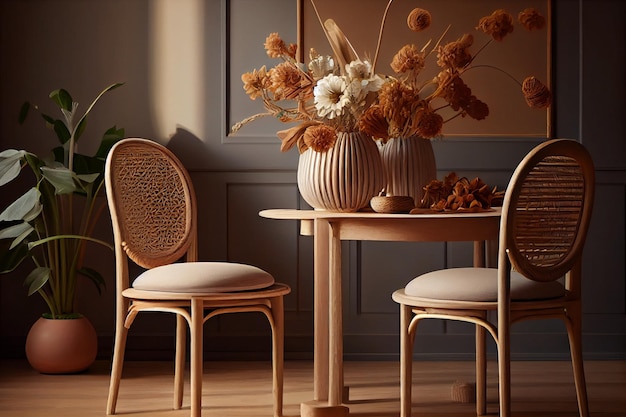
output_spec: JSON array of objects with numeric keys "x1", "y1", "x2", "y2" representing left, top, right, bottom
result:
[{"x1": 105, "y1": 139, "x2": 290, "y2": 417}]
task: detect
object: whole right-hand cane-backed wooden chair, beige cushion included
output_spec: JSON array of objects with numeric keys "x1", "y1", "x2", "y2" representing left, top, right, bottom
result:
[{"x1": 392, "y1": 140, "x2": 594, "y2": 417}]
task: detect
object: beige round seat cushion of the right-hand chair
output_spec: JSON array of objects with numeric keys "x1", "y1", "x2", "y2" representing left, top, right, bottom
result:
[{"x1": 404, "y1": 268, "x2": 565, "y2": 302}]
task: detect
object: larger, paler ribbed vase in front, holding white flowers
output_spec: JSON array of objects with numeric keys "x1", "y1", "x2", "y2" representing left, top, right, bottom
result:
[{"x1": 298, "y1": 132, "x2": 385, "y2": 212}]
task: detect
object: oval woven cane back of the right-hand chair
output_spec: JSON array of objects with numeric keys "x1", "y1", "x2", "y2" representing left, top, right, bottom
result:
[{"x1": 500, "y1": 140, "x2": 594, "y2": 281}]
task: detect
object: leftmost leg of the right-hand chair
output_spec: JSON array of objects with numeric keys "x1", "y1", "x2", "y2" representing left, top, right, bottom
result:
[{"x1": 400, "y1": 304, "x2": 413, "y2": 417}]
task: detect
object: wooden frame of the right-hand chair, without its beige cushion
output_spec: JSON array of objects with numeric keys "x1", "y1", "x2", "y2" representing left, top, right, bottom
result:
[{"x1": 393, "y1": 139, "x2": 595, "y2": 417}]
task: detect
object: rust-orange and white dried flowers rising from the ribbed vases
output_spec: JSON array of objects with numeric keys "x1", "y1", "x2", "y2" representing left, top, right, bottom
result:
[{"x1": 231, "y1": 0, "x2": 552, "y2": 213}]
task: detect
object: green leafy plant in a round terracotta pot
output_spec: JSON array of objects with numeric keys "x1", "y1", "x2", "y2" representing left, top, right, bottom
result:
[{"x1": 0, "y1": 83, "x2": 124, "y2": 373}]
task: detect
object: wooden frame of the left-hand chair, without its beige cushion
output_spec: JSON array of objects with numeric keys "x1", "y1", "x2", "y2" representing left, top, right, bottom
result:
[{"x1": 105, "y1": 138, "x2": 290, "y2": 417}]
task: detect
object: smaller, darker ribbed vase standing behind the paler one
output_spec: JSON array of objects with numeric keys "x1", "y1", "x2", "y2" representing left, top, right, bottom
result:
[{"x1": 381, "y1": 136, "x2": 437, "y2": 205}]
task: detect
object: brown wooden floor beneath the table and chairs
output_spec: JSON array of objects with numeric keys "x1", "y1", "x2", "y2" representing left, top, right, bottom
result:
[{"x1": 0, "y1": 361, "x2": 626, "y2": 417}]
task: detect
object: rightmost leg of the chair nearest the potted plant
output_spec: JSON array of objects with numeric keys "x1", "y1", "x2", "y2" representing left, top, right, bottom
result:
[{"x1": 270, "y1": 296, "x2": 285, "y2": 417}]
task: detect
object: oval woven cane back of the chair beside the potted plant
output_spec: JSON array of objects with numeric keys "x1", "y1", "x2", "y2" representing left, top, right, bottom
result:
[{"x1": 107, "y1": 139, "x2": 196, "y2": 268}]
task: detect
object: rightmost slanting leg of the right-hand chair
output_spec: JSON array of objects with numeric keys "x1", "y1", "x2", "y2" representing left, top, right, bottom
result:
[{"x1": 565, "y1": 304, "x2": 589, "y2": 417}]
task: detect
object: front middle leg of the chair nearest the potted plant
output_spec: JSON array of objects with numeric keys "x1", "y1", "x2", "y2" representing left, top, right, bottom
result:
[{"x1": 190, "y1": 298, "x2": 204, "y2": 417}]
